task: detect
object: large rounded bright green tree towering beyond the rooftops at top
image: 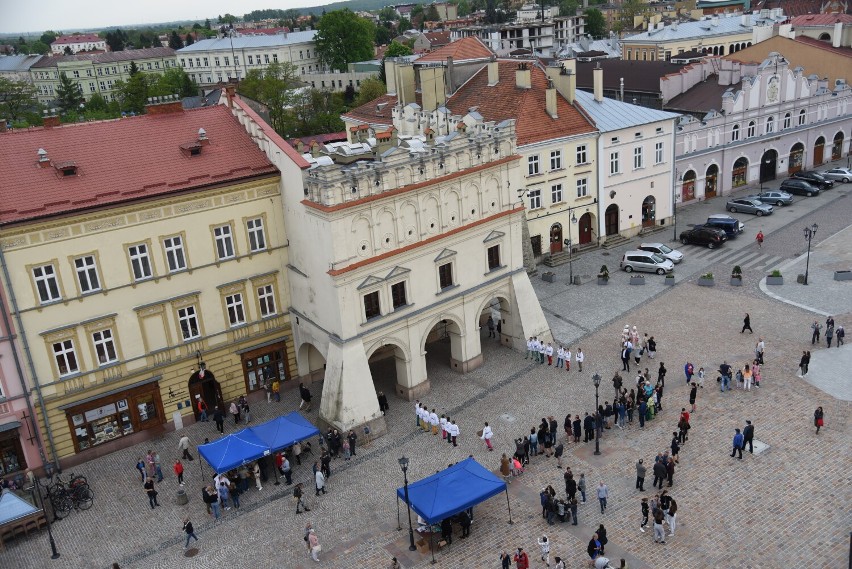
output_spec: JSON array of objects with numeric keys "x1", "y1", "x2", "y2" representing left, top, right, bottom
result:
[{"x1": 314, "y1": 9, "x2": 376, "y2": 72}]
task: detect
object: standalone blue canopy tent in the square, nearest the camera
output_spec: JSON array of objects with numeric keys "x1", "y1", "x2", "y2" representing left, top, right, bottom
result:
[{"x1": 396, "y1": 458, "x2": 514, "y2": 561}]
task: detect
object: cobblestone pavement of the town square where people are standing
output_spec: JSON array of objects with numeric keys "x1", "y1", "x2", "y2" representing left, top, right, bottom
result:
[{"x1": 0, "y1": 170, "x2": 852, "y2": 569}]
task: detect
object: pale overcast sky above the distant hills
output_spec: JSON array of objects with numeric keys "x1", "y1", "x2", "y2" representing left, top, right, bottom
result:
[{"x1": 0, "y1": 0, "x2": 331, "y2": 34}]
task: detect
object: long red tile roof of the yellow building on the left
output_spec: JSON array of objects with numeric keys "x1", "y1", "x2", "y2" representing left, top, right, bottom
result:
[{"x1": 0, "y1": 105, "x2": 278, "y2": 225}]
